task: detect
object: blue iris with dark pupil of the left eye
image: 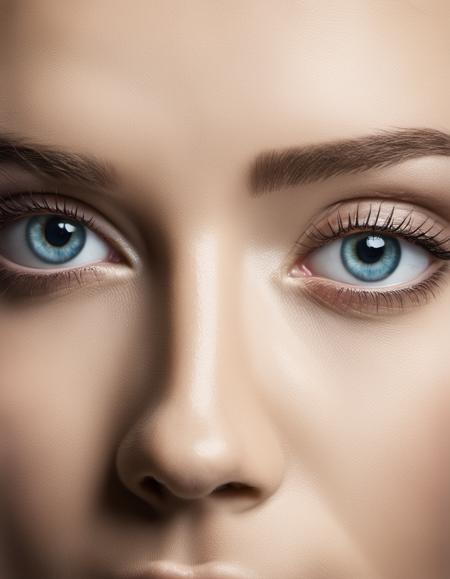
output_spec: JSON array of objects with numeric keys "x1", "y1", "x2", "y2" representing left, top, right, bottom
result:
[{"x1": 26, "y1": 215, "x2": 86, "y2": 264}]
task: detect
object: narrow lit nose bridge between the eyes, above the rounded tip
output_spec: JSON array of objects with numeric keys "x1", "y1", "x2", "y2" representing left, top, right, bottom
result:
[{"x1": 171, "y1": 231, "x2": 232, "y2": 419}]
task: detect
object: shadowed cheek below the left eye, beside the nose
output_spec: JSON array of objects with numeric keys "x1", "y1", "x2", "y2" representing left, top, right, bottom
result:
[{"x1": 0, "y1": 294, "x2": 146, "y2": 559}]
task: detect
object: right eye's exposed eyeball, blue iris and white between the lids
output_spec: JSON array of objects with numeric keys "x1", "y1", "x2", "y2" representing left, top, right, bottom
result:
[{"x1": 304, "y1": 232, "x2": 432, "y2": 287}]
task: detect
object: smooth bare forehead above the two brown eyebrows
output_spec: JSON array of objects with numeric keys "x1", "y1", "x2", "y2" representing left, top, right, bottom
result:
[{"x1": 0, "y1": 0, "x2": 450, "y2": 191}]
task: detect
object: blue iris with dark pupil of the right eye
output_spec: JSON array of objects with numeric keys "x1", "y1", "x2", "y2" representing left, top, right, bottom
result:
[{"x1": 341, "y1": 233, "x2": 402, "y2": 281}]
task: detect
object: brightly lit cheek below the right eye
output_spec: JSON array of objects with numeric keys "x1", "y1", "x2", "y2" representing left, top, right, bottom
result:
[{"x1": 255, "y1": 286, "x2": 450, "y2": 579}]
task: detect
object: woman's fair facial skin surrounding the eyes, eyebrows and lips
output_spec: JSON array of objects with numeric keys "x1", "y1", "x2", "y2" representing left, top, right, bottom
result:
[{"x1": 0, "y1": 0, "x2": 450, "y2": 579}]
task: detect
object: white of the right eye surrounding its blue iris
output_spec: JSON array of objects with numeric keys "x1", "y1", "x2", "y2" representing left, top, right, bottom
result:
[{"x1": 305, "y1": 233, "x2": 432, "y2": 287}]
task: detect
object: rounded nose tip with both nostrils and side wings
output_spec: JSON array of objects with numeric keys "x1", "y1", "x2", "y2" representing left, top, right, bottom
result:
[{"x1": 117, "y1": 406, "x2": 281, "y2": 512}]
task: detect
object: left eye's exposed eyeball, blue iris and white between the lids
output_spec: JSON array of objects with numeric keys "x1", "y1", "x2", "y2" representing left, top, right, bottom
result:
[{"x1": 0, "y1": 214, "x2": 112, "y2": 269}]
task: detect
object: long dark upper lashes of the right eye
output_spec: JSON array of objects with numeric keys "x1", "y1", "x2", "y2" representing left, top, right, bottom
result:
[{"x1": 295, "y1": 202, "x2": 450, "y2": 260}]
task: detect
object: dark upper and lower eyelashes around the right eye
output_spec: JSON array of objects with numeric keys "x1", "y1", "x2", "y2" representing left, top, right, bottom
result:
[{"x1": 294, "y1": 201, "x2": 450, "y2": 314}]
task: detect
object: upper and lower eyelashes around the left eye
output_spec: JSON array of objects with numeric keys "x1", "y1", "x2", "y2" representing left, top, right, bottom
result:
[{"x1": 0, "y1": 191, "x2": 119, "y2": 297}]
